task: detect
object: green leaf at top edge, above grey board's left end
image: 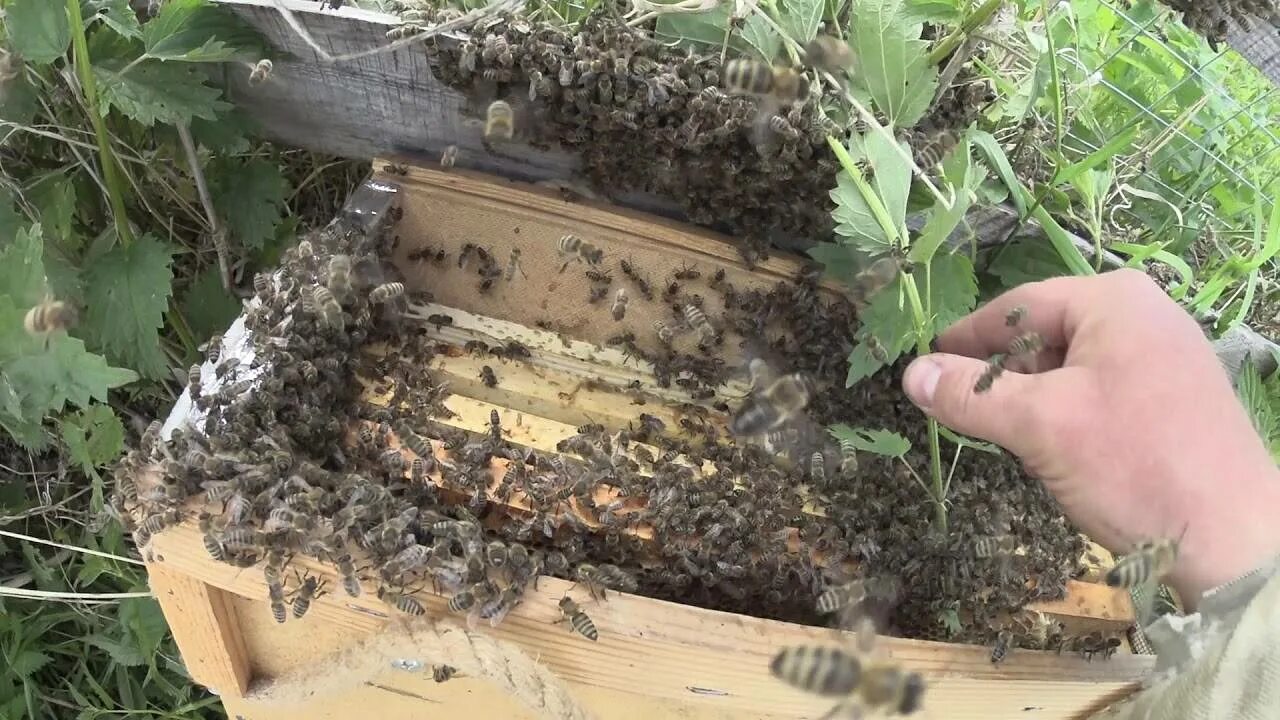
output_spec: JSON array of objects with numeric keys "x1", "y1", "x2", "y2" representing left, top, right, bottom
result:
[{"x1": 142, "y1": 0, "x2": 266, "y2": 63}]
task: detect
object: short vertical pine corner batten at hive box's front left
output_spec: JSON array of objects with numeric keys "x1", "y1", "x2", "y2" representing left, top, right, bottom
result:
[{"x1": 147, "y1": 562, "x2": 250, "y2": 697}]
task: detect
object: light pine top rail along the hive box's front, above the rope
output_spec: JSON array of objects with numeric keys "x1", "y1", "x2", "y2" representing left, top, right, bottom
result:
[{"x1": 152, "y1": 525, "x2": 1153, "y2": 720}]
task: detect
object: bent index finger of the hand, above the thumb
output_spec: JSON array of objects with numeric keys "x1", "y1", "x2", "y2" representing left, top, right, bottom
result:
[{"x1": 938, "y1": 278, "x2": 1096, "y2": 357}]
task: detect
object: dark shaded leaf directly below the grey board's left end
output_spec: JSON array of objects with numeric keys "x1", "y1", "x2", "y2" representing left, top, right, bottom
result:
[{"x1": 209, "y1": 159, "x2": 288, "y2": 250}]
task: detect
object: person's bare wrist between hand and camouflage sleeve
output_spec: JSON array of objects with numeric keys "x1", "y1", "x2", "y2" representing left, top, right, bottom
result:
[{"x1": 1166, "y1": 462, "x2": 1280, "y2": 602}]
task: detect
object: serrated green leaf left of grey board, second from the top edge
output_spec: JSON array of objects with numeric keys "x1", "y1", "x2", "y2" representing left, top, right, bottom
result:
[{"x1": 93, "y1": 59, "x2": 230, "y2": 127}]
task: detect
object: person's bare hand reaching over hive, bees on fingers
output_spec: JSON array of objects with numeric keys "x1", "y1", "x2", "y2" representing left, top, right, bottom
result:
[{"x1": 902, "y1": 270, "x2": 1280, "y2": 605}]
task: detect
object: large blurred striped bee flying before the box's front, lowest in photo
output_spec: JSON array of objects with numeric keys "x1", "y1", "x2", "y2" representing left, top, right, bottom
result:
[{"x1": 769, "y1": 614, "x2": 925, "y2": 717}]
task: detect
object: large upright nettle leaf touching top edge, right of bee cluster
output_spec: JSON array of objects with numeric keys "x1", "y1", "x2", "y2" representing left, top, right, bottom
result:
[{"x1": 849, "y1": 0, "x2": 938, "y2": 127}]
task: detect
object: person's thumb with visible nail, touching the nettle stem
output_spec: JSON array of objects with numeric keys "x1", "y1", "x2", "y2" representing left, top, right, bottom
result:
[{"x1": 902, "y1": 352, "x2": 1052, "y2": 457}]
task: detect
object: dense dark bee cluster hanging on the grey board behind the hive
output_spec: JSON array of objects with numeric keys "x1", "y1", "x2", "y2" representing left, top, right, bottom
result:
[{"x1": 401, "y1": 3, "x2": 989, "y2": 260}]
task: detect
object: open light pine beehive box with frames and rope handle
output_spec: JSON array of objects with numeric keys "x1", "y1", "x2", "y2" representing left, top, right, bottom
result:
[{"x1": 148, "y1": 163, "x2": 1155, "y2": 720}]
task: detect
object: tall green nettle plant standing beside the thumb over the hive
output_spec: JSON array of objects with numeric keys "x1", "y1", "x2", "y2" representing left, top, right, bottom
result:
[{"x1": 810, "y1": 1, "x2": 998, "y2": 530}]
